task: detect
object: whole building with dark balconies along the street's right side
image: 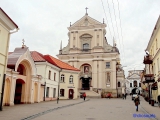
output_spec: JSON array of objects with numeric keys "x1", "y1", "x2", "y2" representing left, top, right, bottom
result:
[{"x1": 142, "y1": 16, "x2": 160, "y2": 101}]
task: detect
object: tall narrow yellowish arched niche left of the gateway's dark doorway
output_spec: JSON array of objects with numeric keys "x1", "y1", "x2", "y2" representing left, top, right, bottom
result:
[{"x1": 3, "y1": 78, "x2": 11, "y2": 106}]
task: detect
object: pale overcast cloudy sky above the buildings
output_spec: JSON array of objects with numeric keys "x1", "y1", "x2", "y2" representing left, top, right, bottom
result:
[{"x1": 0, "y1": 0, "x2": 160, "y2": 76}]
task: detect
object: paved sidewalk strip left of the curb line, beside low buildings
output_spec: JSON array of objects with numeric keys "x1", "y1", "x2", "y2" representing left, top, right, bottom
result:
[{"x1": 0, "y1": 99, "x2": 87, "y2": 120}]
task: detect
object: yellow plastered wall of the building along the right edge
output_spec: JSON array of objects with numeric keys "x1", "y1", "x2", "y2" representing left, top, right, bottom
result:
[{"x1": 144, "y1": 16, "x2": 160, "y2": 101}]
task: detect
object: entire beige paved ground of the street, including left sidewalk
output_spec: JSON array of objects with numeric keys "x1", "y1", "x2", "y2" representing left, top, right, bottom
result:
[{"x1": 0, "y1": 96, "x2": 160, "y2": 120}]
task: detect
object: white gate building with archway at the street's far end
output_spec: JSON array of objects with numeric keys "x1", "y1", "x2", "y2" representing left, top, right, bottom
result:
[{"x1": 126, "y1": 70, "x2": 142, "y2": 94}]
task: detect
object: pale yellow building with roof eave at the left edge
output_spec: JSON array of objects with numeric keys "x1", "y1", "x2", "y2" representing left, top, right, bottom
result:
[{"x1": 0, "y1": 8, "x2": 18, "y2": 110}]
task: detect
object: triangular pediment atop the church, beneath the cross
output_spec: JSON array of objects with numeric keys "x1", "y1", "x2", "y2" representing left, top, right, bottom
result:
[{"x1": 68, "y1": 15, "x2": 106, "y2": 29}]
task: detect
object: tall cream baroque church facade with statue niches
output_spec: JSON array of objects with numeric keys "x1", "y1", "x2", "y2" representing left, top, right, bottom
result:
[{"x1": 57, "y1": 13, "x2": 120, "y2": 97}]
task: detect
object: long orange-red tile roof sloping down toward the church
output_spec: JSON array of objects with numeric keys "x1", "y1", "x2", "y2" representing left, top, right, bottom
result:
[{"x1": 44, "y1": 55, "x2": 80, "y2": 71}]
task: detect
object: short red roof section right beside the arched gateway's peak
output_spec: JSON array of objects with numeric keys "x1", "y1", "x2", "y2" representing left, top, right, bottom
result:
[{"x1": 31, "y1": 51, "x2": 46, "y2": 62}]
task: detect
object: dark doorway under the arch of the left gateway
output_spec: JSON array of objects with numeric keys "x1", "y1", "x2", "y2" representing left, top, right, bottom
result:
[{"x1": 14, "y1": 79, "x2": 24, "y2": 104}]
